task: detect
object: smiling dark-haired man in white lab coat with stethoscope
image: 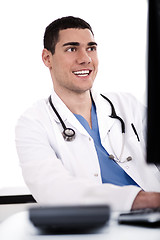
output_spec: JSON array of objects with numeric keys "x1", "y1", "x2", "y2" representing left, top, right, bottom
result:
[{"x1": 16, "y1": 17, "x2": 160, "y2": 211}]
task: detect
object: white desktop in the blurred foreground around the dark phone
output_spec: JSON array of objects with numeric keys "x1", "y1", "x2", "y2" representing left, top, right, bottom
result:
[{"x1": 0, "y1": 211, "x2": 160, "y2": 240}]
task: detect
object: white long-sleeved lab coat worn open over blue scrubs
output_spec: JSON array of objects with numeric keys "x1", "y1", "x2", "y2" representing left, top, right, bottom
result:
[{"x1": 16, "y1": 91, "x2": 160, "y2": 211}]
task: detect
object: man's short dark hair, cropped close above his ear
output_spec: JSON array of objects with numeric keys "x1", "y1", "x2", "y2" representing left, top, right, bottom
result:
[{"x1": 43, "y1": 16, "x2": 94, "y2": 54}]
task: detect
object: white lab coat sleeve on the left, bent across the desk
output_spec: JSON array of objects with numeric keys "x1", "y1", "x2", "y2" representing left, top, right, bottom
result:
[{"x1": 16, "y1": 104, "x2": 140, "y2": 211}]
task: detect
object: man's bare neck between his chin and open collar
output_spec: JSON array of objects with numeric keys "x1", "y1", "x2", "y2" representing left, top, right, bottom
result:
[{"x1": 55, "y1": 90, "x2": 92, "y2": 128}]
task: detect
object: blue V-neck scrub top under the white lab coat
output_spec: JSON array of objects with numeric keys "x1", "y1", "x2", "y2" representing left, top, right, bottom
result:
[{"x1": 74, "y1": 102, "x2": 138, "y2": 186}]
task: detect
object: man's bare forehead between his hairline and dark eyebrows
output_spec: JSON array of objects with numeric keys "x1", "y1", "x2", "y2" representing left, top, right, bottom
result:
[{"x1": 57, "y1": 28, "x2": 94, "y2": 45}]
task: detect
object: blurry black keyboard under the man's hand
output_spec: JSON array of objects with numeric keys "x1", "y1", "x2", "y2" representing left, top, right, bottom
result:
[{"x1": 118, "y1": 207, "x2": 160, "y2": 227}]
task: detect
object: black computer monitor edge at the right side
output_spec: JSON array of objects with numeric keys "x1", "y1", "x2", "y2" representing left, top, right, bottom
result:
[{"x1": 147, "y1": 0, "x2": 160, "y2": 165}]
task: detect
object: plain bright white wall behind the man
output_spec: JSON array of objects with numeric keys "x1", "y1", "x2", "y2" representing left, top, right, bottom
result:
[{"x1": 0, "y1": 0, "x2": 147, "y2": 188}]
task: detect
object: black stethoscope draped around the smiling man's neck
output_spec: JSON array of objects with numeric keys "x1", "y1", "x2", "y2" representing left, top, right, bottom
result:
[{"x1": 48, "y1": 94, "x2": 140, "y2": 163}]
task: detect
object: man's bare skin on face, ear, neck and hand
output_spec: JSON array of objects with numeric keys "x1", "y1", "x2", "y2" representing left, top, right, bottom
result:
[{"x1": 42, "y1": 28, "x2": 160, "y2": 210}]
